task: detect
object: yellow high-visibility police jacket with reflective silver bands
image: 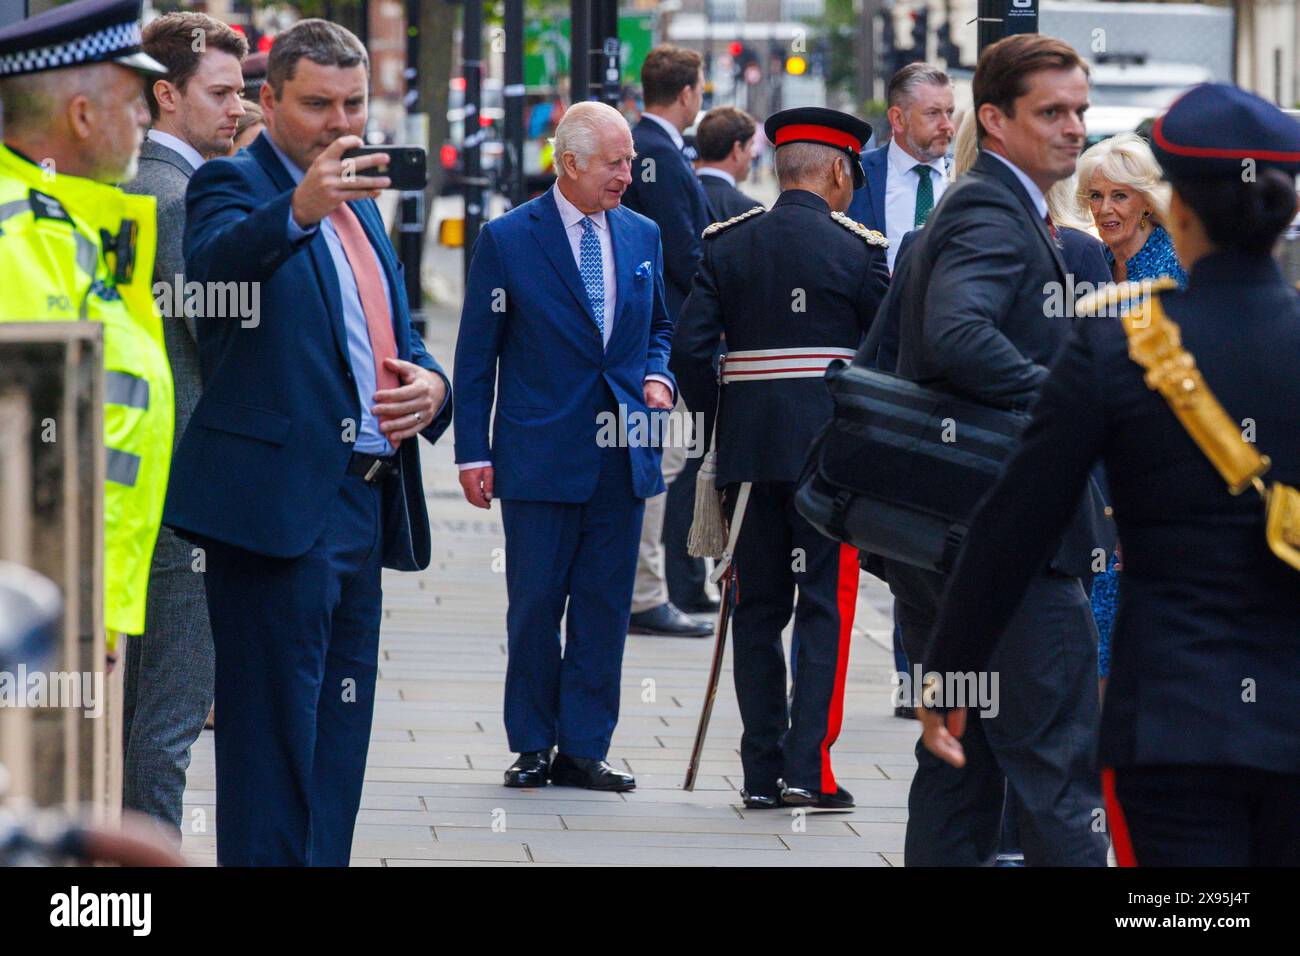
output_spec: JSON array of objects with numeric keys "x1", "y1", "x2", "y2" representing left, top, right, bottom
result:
[{"x1": 0, "y1": 146, "x2": 176, "y2": 635}]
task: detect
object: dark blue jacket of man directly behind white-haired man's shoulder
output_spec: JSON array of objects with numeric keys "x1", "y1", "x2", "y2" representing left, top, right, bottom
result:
[{"x1": 623, "y1": 117, "x2": 711, "y2": 323}]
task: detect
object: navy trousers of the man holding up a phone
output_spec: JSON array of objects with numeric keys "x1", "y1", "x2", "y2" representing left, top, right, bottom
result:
[{"x1": 204, "y1": 476, "x2": 384, "y2": 866}]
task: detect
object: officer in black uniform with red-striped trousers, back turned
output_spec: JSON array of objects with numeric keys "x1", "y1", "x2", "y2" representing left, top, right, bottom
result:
[{"x1": 672, "y1": 108, "x2": 889, "y2": 809}]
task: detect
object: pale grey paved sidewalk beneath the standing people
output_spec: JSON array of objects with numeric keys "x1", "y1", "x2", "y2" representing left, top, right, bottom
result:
[{"x1": 185, "y1": 304, "x2": 917, "y2": 866}]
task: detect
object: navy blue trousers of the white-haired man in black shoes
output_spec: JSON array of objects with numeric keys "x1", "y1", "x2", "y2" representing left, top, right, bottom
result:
[{"x1": 501, "y1": 447, "x2": 645, "y2": 760}]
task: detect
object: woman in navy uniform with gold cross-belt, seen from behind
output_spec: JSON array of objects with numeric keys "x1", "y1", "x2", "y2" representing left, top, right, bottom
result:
[{"x1": 923, "y1": 85, "x2": 1300, "y2": 866}]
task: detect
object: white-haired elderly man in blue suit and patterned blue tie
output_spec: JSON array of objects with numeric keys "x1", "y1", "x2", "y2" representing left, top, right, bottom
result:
[{"x1": 455, "y1": 103, "x2": 676, "y2": 791}]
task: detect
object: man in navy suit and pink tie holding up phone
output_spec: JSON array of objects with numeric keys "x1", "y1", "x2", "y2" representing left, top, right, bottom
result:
[{"x1": 165, "y1": 20, "x2": 451, "y2": 866}]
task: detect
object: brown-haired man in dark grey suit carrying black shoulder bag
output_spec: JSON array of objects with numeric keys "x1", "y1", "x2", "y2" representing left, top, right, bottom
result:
[{"x1": 887, "y1": 34, "x2": 1113, "y2": 866}]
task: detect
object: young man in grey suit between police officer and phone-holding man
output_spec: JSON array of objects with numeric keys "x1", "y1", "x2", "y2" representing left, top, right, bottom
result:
[{"x1": 122, "y1": 13, "x2": 248, "y2": 838}]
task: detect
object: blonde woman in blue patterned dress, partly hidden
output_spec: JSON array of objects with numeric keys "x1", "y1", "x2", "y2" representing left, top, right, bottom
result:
[{"x1": 1078, "y1": 133, "x2": 1187, "y2": 685}]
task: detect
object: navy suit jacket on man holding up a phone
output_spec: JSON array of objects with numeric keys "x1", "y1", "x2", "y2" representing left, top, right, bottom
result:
[{"x1": 164, "y1": 133, "x2": 451, "y2": 571}]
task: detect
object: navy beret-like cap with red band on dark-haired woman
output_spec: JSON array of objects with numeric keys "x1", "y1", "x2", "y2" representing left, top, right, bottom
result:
[{"x1": 1151, "y1": 83, "x2": 1300, "y2": 182}]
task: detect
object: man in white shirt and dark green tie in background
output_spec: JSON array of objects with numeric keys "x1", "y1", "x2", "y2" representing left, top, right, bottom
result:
[{"x1": 848, "y1": 62, "x2": 957, "y2": 272}]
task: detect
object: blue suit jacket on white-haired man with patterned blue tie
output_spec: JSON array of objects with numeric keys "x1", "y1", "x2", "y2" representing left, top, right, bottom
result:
[{"x1": 454, "y1": 186, "x2": 675, "y2": 502}]
